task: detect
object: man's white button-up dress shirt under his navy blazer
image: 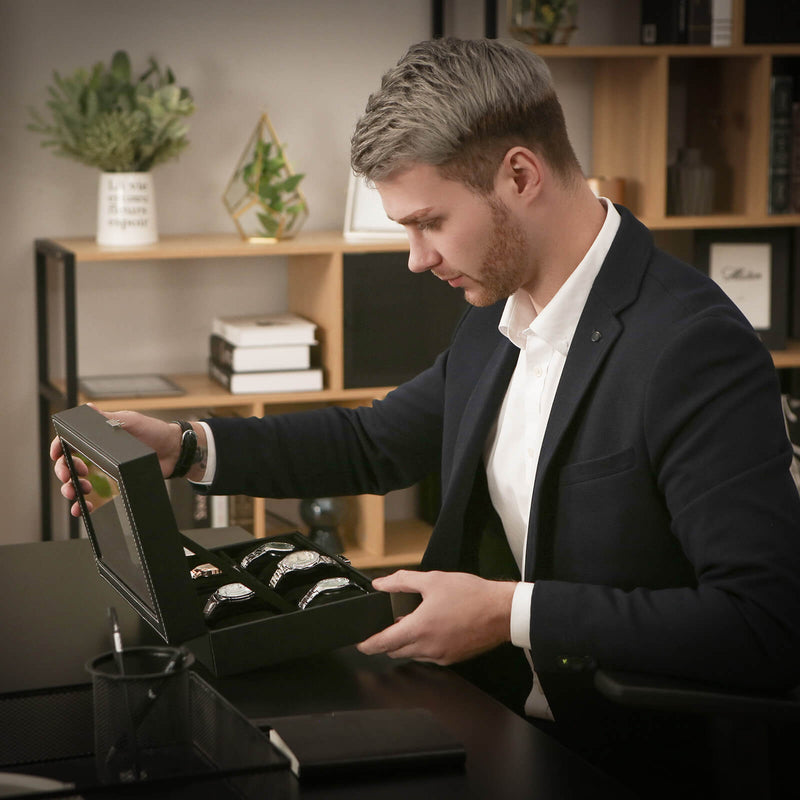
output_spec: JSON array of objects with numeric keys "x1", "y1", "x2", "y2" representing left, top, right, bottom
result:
[{"x1": 484, "y1": 198, "x2": 620, "y2": 719}]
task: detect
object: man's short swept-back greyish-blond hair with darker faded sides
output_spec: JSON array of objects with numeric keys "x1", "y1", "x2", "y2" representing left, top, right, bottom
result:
[{"x1": 351, "y1": 38, "x2": 581, "y2": 192}]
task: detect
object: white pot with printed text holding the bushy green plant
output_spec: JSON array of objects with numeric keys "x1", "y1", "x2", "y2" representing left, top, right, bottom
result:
[{"x1": 97, "y1": 172, "x2": 158, "y2": 247}]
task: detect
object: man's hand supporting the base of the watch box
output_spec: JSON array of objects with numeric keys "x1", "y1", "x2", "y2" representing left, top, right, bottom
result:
[{"x1": 358, "y1": 570, "x2": 516, "y2": 665}]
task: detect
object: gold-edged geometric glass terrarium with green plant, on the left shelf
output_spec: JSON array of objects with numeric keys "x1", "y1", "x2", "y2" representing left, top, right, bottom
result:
[{"x1": 222, "y1": 114, "x2": 308, "y2": 242}]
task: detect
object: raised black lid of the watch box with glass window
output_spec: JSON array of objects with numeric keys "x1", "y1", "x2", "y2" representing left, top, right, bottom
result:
[{"x1": 52, "y1": 406, "x2": 207, "y2": 642}]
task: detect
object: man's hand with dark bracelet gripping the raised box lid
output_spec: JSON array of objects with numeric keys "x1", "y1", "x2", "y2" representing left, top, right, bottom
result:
[{"x1": 50, "y1": 411, "x2": 188, "y2": 517}]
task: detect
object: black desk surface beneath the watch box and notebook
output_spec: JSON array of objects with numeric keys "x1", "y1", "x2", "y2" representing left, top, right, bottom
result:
[{"x1": 0, "y1": 540, "x2": 627, "y2": 800}]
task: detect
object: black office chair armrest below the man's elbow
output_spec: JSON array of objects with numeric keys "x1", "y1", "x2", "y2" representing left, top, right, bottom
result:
[{"x1": 594, "y1": 669, "x2": 800, "y2": 800}]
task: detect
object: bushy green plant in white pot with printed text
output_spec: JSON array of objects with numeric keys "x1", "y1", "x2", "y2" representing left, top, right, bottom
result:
[{"x1": 28, "y1": 50, "x2": 195, "y2": 246}]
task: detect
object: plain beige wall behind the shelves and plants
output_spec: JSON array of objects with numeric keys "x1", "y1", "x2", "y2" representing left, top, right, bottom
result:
[{"x1": 0, "y1": 0, "x2": 636, "y2": 543}]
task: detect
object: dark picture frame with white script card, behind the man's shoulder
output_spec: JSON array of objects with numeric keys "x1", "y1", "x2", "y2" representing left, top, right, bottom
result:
[{"x1": 694, "y1": 228, "x2": 792, "y2": 350}]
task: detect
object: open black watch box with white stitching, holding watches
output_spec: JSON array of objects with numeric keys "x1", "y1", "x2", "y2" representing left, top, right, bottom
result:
[{"x1": 52, "y1": 406, "x2": 394, "y2": 676}]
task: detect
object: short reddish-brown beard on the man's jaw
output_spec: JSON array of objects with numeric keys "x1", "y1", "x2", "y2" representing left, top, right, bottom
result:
[{"x1": 464, "y1": 197, "x2": 528, "y2": 307}]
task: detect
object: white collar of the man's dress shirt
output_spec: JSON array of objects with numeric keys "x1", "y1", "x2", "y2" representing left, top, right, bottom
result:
[{"x1": 498, "y1": 197, "x2": 620, "y2": 356}]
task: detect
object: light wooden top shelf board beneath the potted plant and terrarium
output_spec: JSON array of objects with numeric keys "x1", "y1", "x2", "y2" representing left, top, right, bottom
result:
[{"x1": 43, "y1": 231, "x2": 408, "y2": 264}]
